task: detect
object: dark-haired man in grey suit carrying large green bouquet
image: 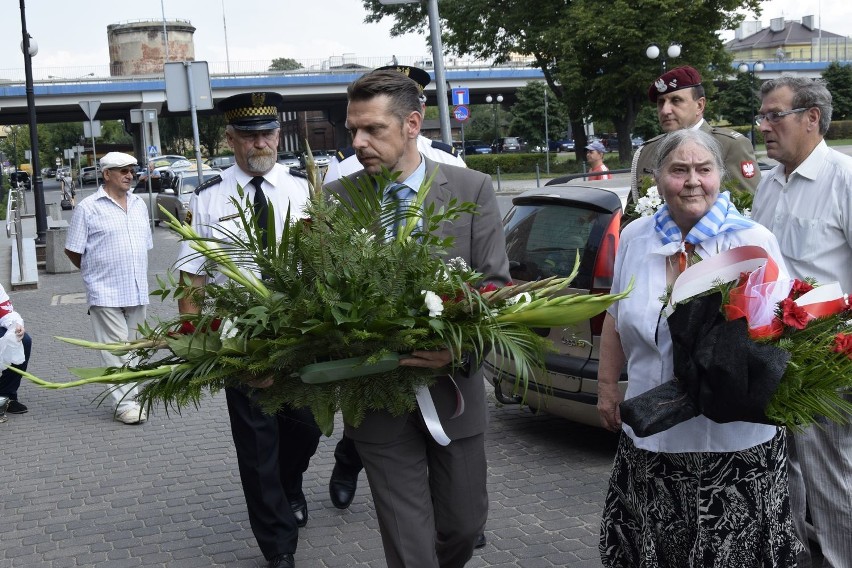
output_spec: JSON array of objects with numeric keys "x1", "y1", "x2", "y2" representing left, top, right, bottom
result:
[{"x1": 327, "y1": 71, "x2": 509, "y2": 568}]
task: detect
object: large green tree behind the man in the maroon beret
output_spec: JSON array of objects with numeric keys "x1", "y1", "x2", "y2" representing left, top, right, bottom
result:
[{"x1": 362, "y1": 0, "x2": 760, "y2": 161}]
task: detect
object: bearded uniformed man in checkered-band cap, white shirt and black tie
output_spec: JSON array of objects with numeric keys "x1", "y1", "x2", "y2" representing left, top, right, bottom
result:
[{"x1": 176, "y1": 92, "x2": 320, "y2": 568}]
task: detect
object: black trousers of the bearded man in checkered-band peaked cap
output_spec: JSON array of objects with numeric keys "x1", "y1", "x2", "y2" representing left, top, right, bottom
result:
[{"x1": 225, "y1": 388, "x2": 320, "y2": 560}]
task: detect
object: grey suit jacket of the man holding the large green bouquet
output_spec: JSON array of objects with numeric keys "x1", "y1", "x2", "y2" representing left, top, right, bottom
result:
[{"x1": 327, "y1": 158, "x2": 510, "y2": 443}]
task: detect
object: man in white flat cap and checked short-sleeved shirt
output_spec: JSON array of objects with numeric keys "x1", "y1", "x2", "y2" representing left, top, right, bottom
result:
[{"x1": 65, "y1": 152, "x2": 154, "y2": 424}]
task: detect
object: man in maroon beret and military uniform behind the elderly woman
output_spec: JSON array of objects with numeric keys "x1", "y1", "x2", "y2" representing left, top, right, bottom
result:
[{"x1": 630, "y1": 66, "x2": 760, "y2": 201}]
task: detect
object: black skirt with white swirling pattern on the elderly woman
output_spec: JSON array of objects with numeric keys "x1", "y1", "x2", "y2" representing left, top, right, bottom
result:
[{"x1": 600, "y1": 430, "x2": 801, "y2": 568}]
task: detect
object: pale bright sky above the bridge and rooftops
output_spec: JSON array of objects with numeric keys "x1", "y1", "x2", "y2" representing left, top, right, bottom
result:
[{"x1": 0, "y1": 0, "x2": 852, "y2": 78}]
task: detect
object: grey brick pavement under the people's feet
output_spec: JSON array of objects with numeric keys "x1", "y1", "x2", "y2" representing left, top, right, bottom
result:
[{"x1": 0, "y1": 184, "x2": 615, "y2": 568}]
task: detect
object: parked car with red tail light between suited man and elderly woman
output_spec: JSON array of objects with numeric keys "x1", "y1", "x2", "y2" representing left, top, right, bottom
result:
[{"x1": 484, "y1": 176, "x2": 630, "y2": 426}]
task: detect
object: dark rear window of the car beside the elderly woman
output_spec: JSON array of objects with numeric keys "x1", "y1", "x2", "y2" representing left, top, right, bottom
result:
[{"x1": 504, "y1": 203, "x2": 612, "y2": 288}]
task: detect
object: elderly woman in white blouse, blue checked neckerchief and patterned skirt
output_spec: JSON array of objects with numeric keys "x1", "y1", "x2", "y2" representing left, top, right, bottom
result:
[{"x1": 598, "y1": 129, "x2": 800, "y2": 568}]
